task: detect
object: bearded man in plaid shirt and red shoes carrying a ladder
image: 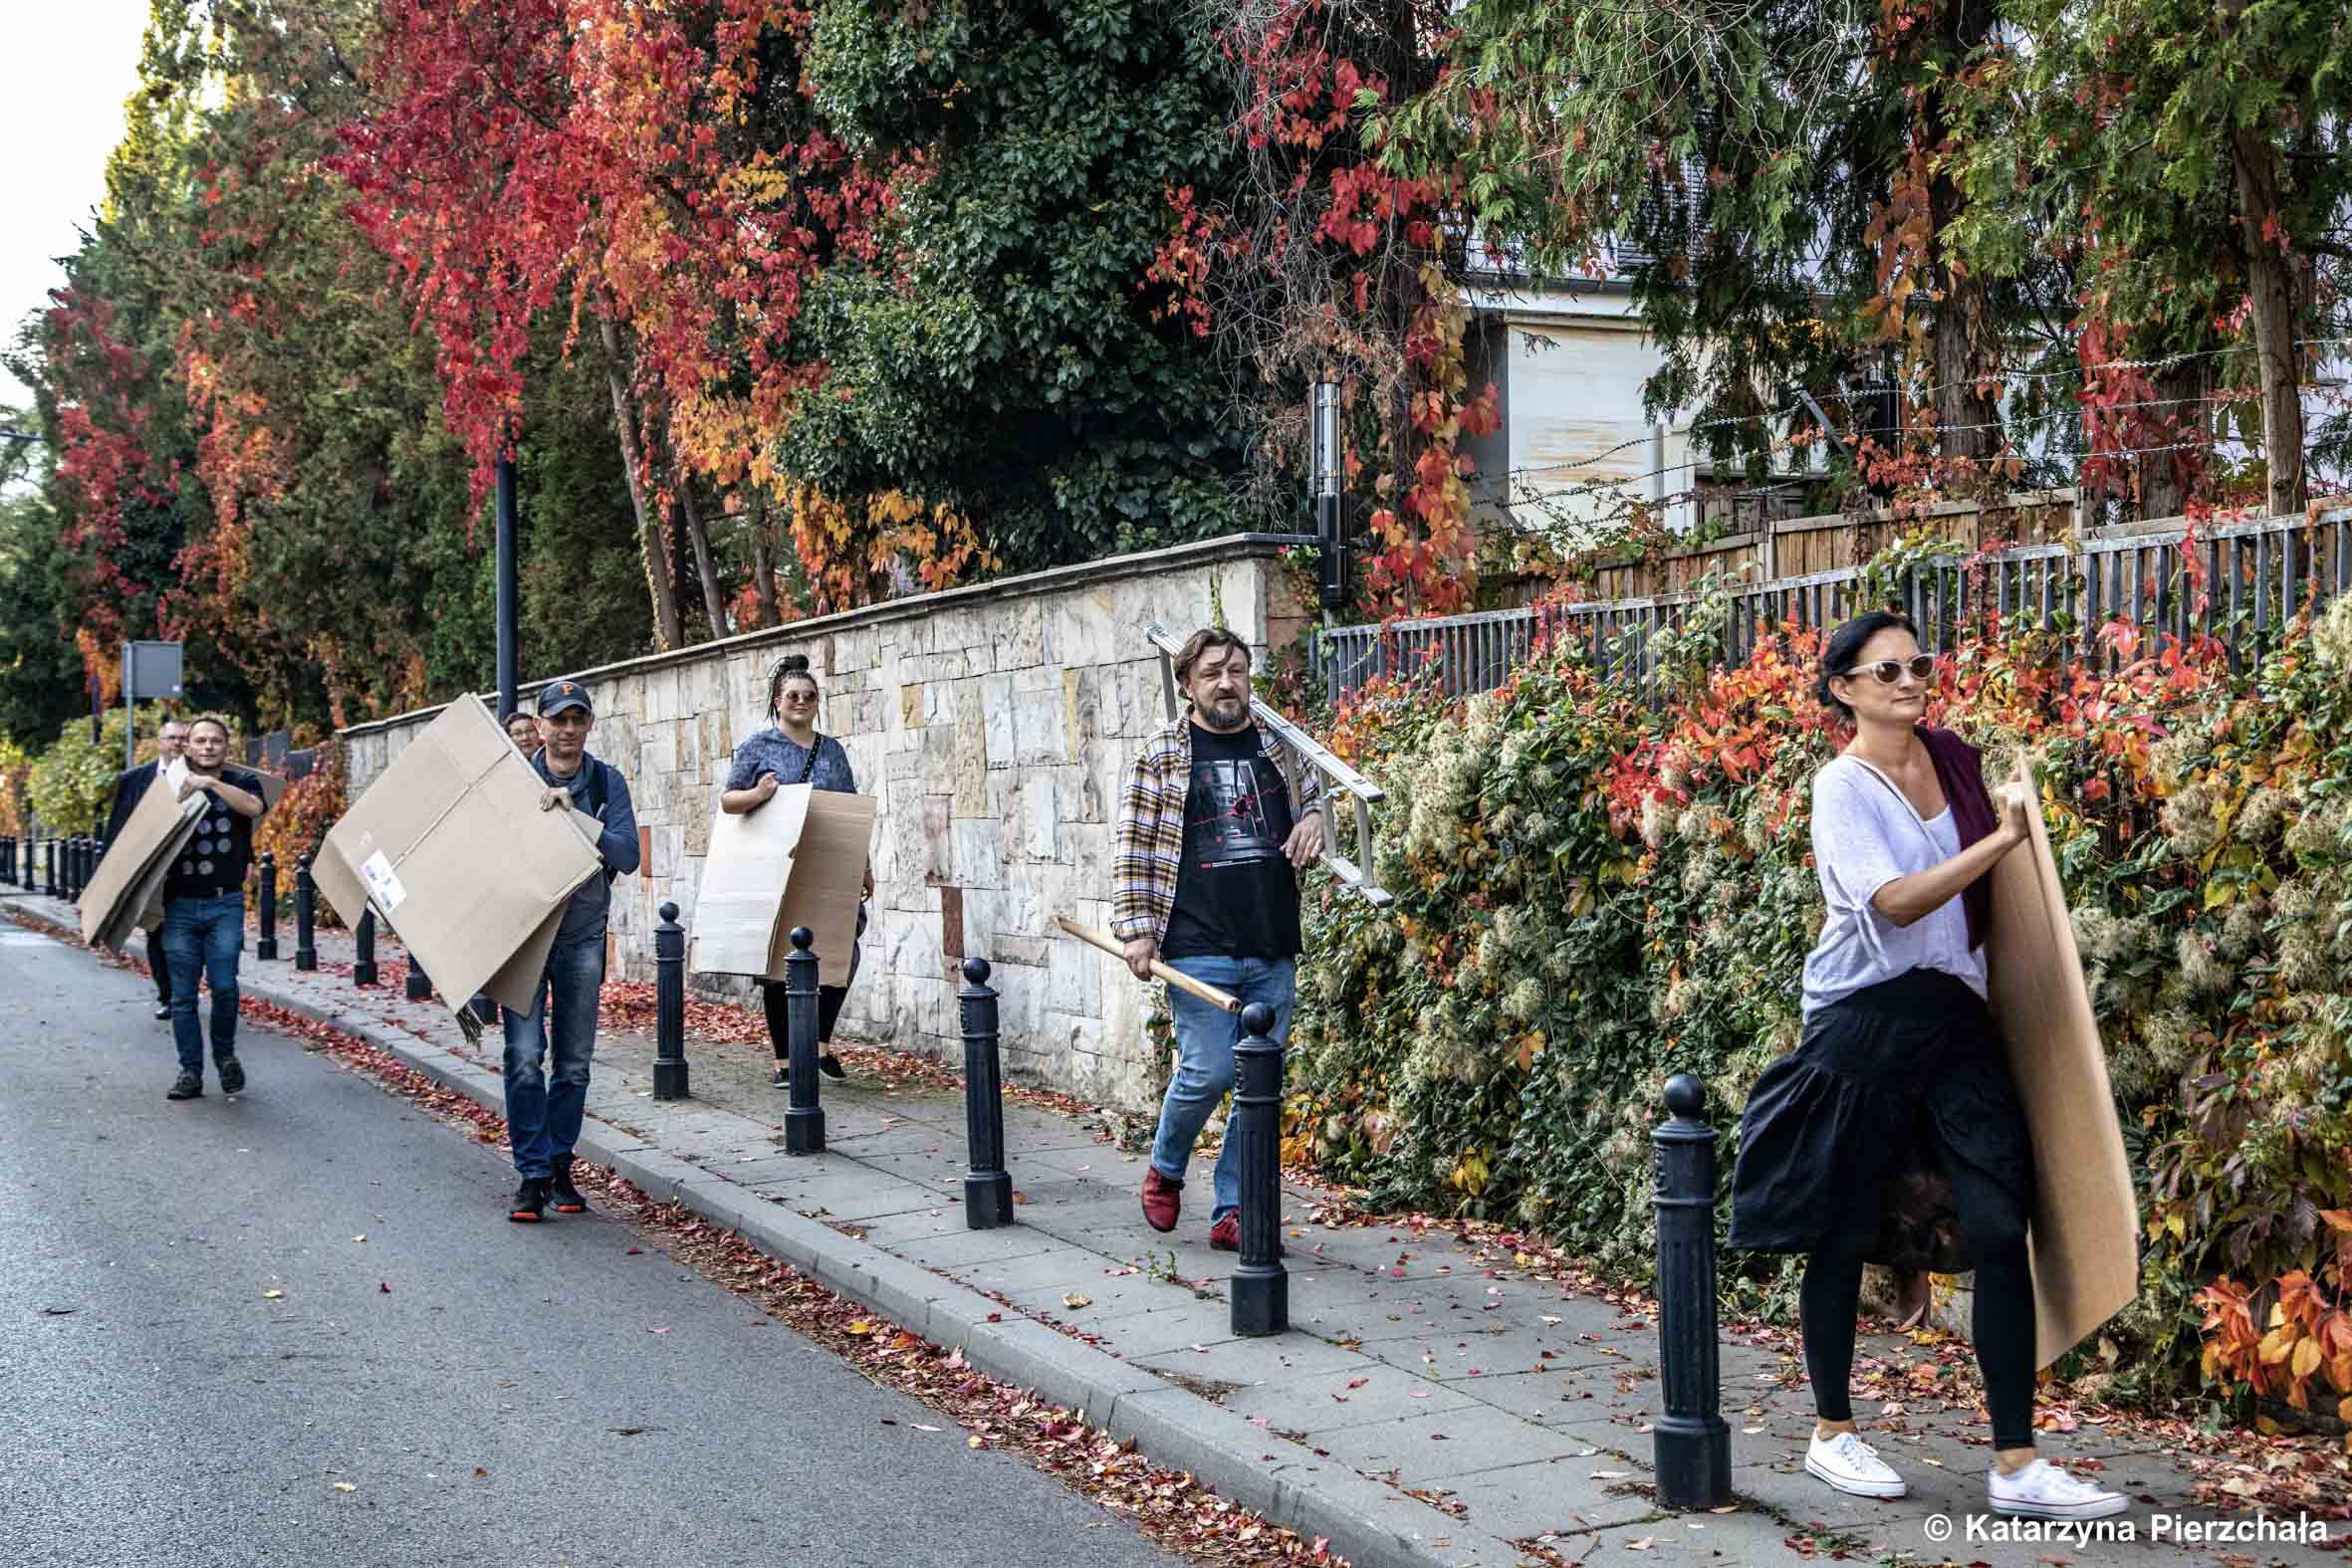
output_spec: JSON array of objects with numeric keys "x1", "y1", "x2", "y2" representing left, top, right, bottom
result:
[{"x1": 1110, "y1": 627, "x2": 1321, "y2": 1250}]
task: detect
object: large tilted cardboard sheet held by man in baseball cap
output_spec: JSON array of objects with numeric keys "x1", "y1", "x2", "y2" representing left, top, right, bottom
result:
[{"x1": 311, "y1": 696, "x2": 604, "y2": 1010}]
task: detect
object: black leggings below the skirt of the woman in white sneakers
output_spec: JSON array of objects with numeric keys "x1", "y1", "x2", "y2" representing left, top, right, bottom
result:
[{"x1": 1797, "y1": 1161, "x2": 2034, "y2": 1449}]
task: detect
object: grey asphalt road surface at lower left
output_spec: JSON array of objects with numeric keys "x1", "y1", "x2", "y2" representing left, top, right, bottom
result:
[{"x1": 0, "y1": 922, "x2": 1176, "y2": 1568}]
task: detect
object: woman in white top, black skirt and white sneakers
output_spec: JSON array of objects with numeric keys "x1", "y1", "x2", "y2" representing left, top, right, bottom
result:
[{"x1": 1731, "y1": 611, "x2": 2126, "y2": 1518}]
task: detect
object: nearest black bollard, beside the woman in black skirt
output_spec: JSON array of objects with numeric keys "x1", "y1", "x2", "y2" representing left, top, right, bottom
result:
[{"x1": 1651, "y1": 1072, "x2": 1731, "y2": 1509}]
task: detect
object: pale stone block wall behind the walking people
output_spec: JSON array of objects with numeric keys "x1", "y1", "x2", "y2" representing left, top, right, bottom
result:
[{"x1": 344, "y1": 534, "x2": 1307, "y2": 1107}]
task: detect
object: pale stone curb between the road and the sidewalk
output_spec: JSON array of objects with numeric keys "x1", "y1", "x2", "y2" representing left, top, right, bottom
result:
[{"x1": 5, "y1": 896, "x2": 1520, "y2": 1568}]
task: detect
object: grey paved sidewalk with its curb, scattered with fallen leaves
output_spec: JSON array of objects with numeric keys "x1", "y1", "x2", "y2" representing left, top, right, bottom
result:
[{"x1": 0, "y1": 896, "x2": 2352, "y2": 1568}]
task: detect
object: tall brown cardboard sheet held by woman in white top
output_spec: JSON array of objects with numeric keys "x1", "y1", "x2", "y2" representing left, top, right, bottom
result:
[{"x1": 1986, "y1": 769, "x2": 2140, "y2": 1366}]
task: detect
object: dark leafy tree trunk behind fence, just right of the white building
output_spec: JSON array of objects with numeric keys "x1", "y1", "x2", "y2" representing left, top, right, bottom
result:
[{"x1": 1919, "y1": 0, "x2": 2001, "y2": 480}]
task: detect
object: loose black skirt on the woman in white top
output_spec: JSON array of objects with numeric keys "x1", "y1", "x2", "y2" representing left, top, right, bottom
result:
[{"x1": 1731, "y1": 969, "x2": 2034, "y2": 1274}]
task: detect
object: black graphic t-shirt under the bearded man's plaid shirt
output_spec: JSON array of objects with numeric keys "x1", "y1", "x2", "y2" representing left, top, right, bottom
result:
[{"x1": 1159, "y1": 724, "x2": 1298, "y2": 959}]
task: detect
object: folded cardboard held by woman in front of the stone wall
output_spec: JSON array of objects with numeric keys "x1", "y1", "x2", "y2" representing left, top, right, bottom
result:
[{"x1": 691, "y1": 785, "x2": 875, "y2": 985}]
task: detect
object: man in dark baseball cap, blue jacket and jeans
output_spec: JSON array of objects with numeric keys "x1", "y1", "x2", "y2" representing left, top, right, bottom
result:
[{"x1": 499, "y1": 682, "x2": 637, "y2": 1225}]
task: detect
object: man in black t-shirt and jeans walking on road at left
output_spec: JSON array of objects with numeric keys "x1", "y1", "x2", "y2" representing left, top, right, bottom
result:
[{"x1": 162, "y1": 717, "x2": 264, "y2": 1100}]
